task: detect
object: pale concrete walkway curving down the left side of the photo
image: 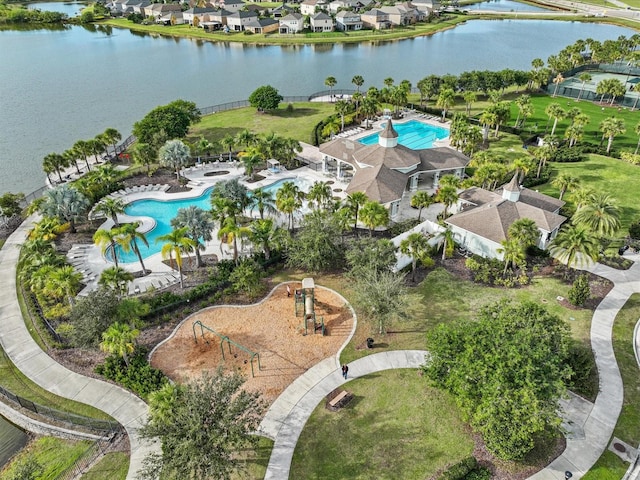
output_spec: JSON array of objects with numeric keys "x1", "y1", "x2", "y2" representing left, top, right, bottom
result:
[{"x1": 0, "y1": 217, "x2": 159, "y2": 480}]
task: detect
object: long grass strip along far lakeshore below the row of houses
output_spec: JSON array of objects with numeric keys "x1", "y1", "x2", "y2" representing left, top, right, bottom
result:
[{"x1": 101, "y1": 15, "x2": 471, "y2": 45}]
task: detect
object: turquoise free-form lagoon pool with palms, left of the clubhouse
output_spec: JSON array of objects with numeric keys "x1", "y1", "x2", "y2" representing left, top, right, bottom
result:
[{"x1": 107, "y1": 178, "x2": 311, "y2": 263}]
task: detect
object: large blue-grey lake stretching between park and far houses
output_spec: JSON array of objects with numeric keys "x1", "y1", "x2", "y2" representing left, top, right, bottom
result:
[{"x1": 0, "y1": 16, "x2": 634, "y2": 193}]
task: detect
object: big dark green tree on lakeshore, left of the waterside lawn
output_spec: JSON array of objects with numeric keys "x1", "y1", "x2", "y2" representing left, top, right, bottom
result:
[{"x1": 133, "y1": 100, "x2": 200, "y2": 143}]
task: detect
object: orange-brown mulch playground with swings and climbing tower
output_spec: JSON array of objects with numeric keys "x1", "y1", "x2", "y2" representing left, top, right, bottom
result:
[{"x1": 151, "y1": 279, "x2": 354, "y2": 403}]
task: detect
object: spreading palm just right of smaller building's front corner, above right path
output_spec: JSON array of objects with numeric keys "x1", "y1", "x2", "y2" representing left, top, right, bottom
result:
[{"x1": 549, "y1": 225, "x2": 600, "y2": 268}]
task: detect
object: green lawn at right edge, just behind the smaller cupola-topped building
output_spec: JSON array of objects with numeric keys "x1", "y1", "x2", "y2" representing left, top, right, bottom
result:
[{"x1": 536, "y1": 155, "x2": 640, "y2": 230}]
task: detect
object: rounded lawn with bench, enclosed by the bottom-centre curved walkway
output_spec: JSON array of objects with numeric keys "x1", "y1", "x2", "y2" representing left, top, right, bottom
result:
[{"x1": 289, "y1": 370, "x2": 473, "y2": 480}]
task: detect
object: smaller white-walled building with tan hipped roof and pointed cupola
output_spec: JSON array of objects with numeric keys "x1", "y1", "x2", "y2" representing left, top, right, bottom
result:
[{"x1": 445, "y1": 174, "x2": 566, "y2": 260}]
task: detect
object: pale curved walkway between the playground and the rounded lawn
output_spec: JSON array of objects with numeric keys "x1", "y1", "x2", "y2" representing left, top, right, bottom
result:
[{"x1": 259, "y1": 350, "x2": 427, "y2": 480}]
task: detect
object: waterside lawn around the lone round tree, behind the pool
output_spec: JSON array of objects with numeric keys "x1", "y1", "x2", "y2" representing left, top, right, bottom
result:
[{"x1": 189, "y1": 102, "x2": 335, "y2": 143}]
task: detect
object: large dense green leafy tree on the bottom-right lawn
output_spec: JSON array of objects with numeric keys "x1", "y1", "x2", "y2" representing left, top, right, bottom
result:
[{"x1": 424, "y1": 301, "x2": 571, "y2": 460}]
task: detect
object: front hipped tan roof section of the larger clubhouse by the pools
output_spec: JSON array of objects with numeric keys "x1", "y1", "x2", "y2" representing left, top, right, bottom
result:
[{"x1": 346, "y1": 164, "x2": 407, "y2": 203}]
